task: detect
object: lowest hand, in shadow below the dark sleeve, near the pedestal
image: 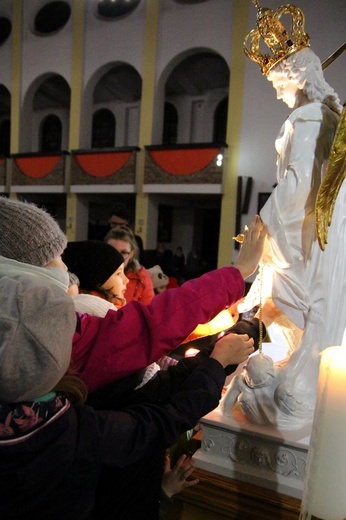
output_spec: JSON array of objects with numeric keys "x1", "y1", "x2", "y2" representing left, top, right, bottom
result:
[{"x1": 162, "y1": 454, "x2": 199, "y2": 498}]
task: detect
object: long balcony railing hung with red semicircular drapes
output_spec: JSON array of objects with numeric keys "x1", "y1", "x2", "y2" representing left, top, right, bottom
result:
[{"x1": 5, "y1": 143, "x2": 227, "y2": 193}]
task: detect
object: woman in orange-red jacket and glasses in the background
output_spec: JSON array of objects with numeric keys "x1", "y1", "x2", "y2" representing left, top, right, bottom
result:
[{"x1": 104, "y1": 226, "x2": 155, "y2": 305}]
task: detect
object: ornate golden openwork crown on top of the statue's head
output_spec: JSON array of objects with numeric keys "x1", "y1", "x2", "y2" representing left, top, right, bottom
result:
[{"x1": 244, "y1": 0, "x2": 310, "y2": 74}]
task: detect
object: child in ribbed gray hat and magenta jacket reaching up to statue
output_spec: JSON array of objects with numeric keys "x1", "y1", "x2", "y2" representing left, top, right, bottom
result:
[{"x1": 0, "y1": 197, "x2": 265, "y2": 392}]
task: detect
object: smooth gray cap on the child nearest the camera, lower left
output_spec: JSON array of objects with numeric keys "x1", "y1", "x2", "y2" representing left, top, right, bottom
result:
[{"x1": 0, "y1": 274, "x2": 76, "y2": 403}]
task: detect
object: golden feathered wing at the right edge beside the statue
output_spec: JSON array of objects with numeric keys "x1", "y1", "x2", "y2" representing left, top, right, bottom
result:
[{"x1": 315, "y1": 105, "x2": 346, "y2": 251}]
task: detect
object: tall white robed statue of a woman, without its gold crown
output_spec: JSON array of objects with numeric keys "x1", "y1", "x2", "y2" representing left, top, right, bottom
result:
[{"x1": 220, "y1": 47, "x2": 346, "y2": 429}]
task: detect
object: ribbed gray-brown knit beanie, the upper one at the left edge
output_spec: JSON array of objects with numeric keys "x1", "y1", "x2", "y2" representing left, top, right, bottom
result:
[{"x1": 0, "y1": 197, "x2": 67, "y2": 267}]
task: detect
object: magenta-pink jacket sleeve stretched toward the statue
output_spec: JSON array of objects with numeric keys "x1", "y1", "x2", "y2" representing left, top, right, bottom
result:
[{"x1": 72, "y1": 267, "x2": 244, "y2": 392}]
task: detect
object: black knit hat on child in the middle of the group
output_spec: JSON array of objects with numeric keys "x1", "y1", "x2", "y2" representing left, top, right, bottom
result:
[{"x1": 62, "y1": 240, "x2": 124, "y2": 291}]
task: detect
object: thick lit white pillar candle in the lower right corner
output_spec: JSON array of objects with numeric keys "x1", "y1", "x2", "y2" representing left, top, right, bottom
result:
[{"x1": 300, "y1": 347, "x2": 346, "y2": 520}]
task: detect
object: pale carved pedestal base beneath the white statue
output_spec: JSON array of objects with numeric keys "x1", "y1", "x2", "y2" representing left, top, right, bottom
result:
[{"x1": 193, "y1": 409, "x2": 311, "y2": 499}]
